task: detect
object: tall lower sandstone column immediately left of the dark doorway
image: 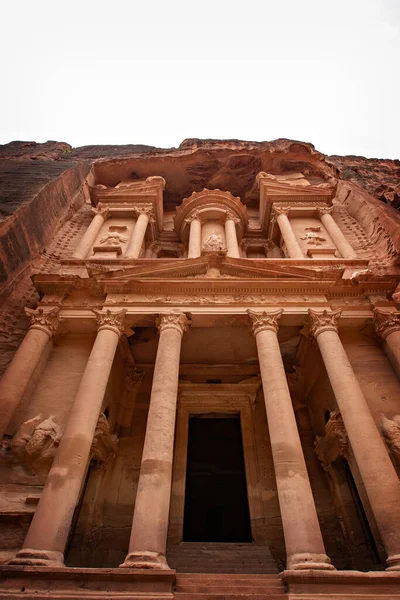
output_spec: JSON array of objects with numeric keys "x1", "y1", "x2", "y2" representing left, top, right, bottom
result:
[{"x1": 120, "y1": 313, "x2": 188, "y2": 569}]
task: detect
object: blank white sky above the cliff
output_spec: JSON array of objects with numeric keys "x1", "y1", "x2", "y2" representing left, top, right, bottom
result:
[{"x1": 0, "y1": 0, "x2": 400, "y2": 158}]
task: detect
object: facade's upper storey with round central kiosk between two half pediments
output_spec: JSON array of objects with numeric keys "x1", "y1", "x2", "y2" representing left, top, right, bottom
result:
[{"x1": 71, "y1": 172, "x2": 359, "y2": 262}]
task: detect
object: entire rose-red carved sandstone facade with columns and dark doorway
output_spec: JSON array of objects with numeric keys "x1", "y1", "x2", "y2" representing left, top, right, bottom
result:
[{"x1": 0, "y1": 140, "x2": 400, "y2": 600}]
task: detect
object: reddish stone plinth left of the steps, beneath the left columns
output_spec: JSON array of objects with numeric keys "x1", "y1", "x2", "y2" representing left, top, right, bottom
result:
[{"x1": 0, "y1": 565, "x2": 175, "y2": 600}]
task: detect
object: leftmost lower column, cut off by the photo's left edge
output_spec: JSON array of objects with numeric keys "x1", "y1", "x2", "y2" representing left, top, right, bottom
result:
[{"x1": 0, "y1": 308, "x2": 59, "y2": 440}]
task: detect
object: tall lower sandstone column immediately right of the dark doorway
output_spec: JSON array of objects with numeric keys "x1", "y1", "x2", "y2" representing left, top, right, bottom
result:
[{"x1": 248, "y1": 310, "x2": 334, "y2": 569}]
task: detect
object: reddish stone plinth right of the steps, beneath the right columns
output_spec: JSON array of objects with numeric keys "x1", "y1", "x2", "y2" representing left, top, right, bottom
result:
[{"x1": 281, "y1": 570, "x2": 400, "y2": 600}]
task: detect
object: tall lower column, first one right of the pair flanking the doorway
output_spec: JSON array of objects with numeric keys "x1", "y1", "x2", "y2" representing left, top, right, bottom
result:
[{"x1": 308, "y1": 309, "x2": 400, "y2": 571}]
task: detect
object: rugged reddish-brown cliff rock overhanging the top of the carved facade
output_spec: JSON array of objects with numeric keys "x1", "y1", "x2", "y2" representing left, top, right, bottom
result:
[{"x1": 0, "y1": 139, "x2": 400, "y2": 292}]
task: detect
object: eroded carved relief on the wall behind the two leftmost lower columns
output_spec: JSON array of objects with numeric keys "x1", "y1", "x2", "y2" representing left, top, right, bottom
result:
[{"x1": 10, "y1": 415, "x2": 62, "y2": 473}]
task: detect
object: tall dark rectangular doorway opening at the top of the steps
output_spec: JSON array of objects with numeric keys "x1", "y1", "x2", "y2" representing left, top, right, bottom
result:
[{"x1": 183, "y1": 415, "x2": 252, "y2": 542}]
